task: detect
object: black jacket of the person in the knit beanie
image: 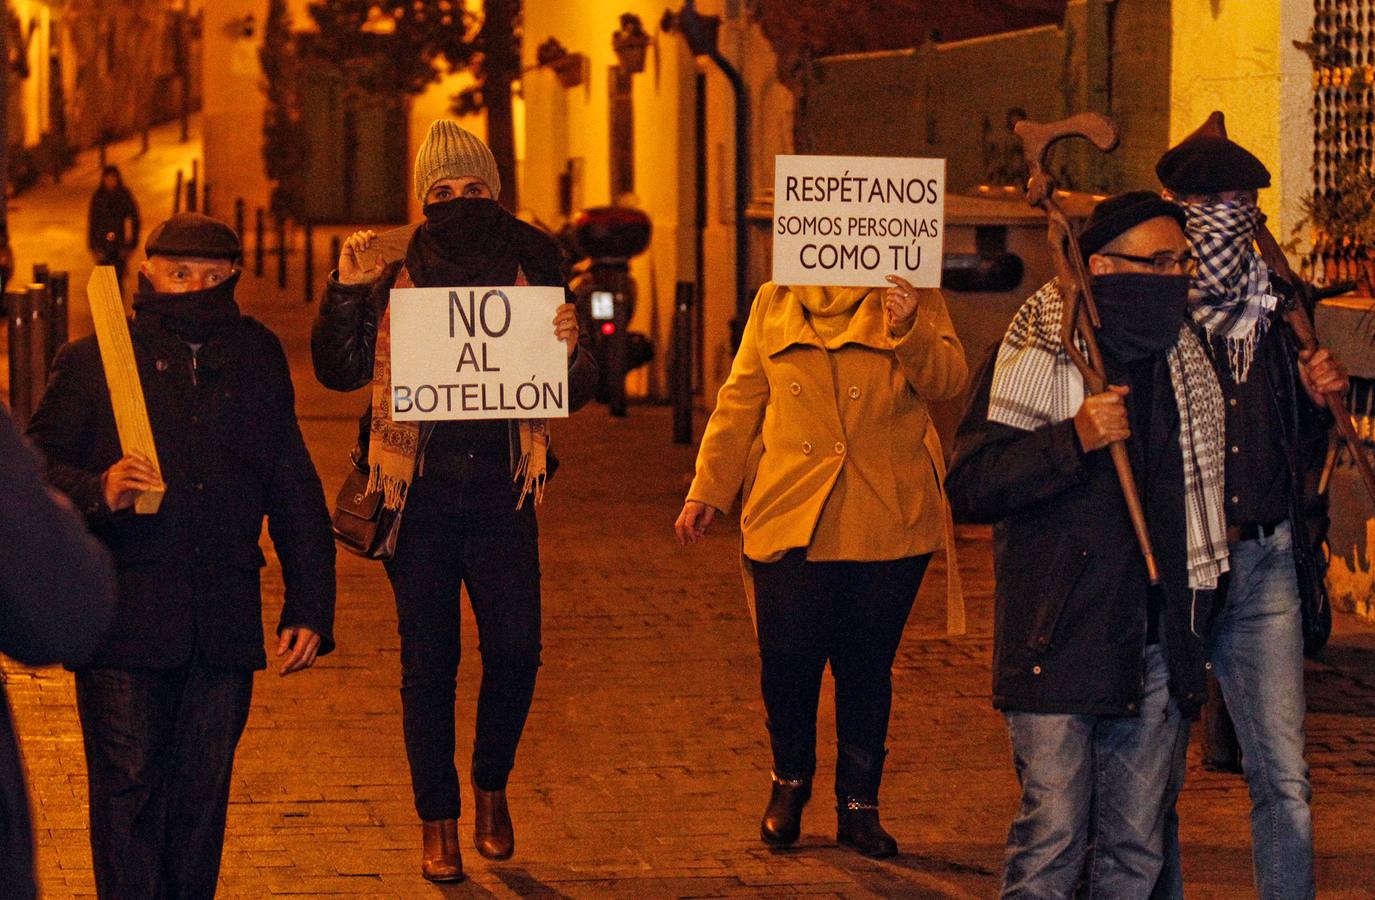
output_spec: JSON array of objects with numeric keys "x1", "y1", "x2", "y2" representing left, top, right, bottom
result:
[{"x1": 311, "y1": 223, "x2": 597, "y2": 477}]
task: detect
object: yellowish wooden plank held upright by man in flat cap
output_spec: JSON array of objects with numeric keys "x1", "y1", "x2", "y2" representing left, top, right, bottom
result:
[{"x1": 87, "y1": 265, "x2": 166, "y2": 515}]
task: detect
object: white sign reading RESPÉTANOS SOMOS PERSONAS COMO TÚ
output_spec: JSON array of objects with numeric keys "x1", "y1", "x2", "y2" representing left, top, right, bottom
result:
[{"x1": 773, "y1": 157, "x2": 946, "y2": 287}]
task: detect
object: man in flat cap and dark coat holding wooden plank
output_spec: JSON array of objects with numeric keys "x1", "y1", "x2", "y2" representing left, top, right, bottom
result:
[{"x1": 29, "y1": 213, "x2": 334, "y2": 897}]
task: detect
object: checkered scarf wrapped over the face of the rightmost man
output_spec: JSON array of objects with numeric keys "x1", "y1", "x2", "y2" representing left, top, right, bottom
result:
[{"x1": 1184, "y1": 201, "x2": 1279, "y2": 383}]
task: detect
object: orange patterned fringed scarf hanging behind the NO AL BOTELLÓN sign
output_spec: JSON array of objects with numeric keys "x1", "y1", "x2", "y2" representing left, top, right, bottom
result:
[{"x1": 367, "y1": 265, "x2": 549, "y2": 510}]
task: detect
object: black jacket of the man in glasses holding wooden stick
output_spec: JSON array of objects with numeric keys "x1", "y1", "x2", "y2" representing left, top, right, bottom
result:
[{"x1": 946, "y1": 357, "x2": 1214, "y2": 716}]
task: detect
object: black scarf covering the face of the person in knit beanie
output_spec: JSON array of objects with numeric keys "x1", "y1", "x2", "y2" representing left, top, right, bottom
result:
[{"x1": 406, "y1": 196, "x2": 521, "y2": 287}]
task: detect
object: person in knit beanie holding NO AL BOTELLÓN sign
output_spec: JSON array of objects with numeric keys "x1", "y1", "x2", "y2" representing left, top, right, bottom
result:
[{"x1": 311, "y1": 120, "x2": 597, "y2": 881}]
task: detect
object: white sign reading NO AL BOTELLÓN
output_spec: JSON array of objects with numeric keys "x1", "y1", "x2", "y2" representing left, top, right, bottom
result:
[{"x1": 391, "y1": 287, "x2": 568, "y2": 422}]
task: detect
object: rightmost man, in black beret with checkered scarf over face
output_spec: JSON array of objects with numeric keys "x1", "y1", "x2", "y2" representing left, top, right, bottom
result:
[{"x1": 1156, "y1": 114, "x2": 1348, "y2": 900}]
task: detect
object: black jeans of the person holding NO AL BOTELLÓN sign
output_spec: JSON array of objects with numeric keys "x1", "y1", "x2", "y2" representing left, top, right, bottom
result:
[{"x1": 386, "y1": 458, "x2": 540, "y2": 822}]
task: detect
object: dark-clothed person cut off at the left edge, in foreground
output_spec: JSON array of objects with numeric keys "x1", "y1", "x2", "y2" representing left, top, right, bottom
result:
[{"x1": 0, "y1": 407, "x2": 114, "y2": 900}]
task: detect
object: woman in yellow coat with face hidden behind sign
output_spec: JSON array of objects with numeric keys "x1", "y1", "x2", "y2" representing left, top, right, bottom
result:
[{"x1": 675, "y1": 276, "x2": 968, "y2": 856}]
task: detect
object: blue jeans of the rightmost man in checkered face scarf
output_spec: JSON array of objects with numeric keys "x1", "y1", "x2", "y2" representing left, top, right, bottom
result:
[{"x1": 1209, "y1": 522, "x2": 1315, "y2": 900}]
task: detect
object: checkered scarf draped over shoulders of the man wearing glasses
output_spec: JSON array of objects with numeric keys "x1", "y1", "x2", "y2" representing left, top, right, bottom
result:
[{"x1": 989, "y1": 279, "x2": 1227, "y2": 589}]
